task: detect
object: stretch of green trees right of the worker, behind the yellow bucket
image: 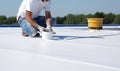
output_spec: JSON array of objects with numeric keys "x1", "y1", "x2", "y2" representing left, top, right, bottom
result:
[{"x1": 56, "y1": 12, "x2": 120, "y2": 24}]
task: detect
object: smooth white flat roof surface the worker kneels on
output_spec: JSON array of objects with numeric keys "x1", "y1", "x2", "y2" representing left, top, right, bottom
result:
[{"x1": 0, "y1": 26, "x2": 120, "y2": 71}]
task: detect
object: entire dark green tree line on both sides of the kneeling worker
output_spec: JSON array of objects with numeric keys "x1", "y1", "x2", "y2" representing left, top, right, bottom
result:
[{"x1": 0, "y1": 12, "x2": 120, "y2": 25}]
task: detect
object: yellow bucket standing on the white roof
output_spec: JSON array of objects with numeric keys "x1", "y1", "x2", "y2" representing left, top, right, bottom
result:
[{"x1": 87, "y1": 18, "x2": 103, "y2": 30}]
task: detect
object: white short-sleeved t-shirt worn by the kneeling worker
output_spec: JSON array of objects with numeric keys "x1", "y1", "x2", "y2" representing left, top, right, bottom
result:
[{"x1": 17, "y1": 0, "x2": 51, "y2": 19}]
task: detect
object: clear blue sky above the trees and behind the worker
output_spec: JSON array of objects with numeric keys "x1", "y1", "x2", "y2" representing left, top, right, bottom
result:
[{"x1": 0, "y1": 0, "x2": 120, "y2": 17}]
